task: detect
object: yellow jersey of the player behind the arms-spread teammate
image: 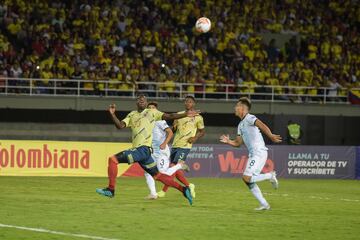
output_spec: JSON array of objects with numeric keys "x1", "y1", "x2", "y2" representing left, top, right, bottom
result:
[{"x1": 172, "y1": 111, "x2": 204, "y2": 148}]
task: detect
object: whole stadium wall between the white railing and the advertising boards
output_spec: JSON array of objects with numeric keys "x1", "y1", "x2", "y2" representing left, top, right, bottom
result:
[{"x1": 0, "y1": 96, "x2": 360, "y2": 146}]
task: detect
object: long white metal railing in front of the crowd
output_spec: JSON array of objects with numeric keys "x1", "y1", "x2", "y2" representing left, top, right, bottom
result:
[{"x1": 0, "y1": 77, "x2": 360, "y2": 103}]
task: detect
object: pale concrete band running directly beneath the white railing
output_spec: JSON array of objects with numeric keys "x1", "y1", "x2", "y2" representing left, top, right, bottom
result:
[{"x1": 0, "y1": 96, "x2": 360, "y2": 116}]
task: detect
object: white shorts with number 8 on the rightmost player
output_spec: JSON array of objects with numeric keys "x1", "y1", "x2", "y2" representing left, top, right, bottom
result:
[{"x1": 243, "y1": 150, "x2": 267, "y2": 177}]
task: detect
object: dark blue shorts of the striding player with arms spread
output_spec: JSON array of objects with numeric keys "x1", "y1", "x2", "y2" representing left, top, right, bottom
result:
[{"x1": 115, "y1": 146, "x2": 159, "y2": 176}]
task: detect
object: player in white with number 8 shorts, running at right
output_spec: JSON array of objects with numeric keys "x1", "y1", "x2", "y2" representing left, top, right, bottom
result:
[{"x1": 220, "y1": 97, "x2": 282, "y2": 210}]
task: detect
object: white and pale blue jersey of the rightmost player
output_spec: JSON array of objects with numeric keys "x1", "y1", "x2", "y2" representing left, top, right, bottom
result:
[{"x1": 238, "y1": 113, "x2": 268, "y2": 154}]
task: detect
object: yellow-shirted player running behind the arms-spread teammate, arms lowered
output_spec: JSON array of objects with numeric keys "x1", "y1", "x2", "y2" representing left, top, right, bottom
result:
[{"x1": 158, "y1": 96, "x2": 205, "y2": 198}]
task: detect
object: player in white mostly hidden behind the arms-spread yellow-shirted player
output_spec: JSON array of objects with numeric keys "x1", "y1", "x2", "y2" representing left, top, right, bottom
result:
[{"x1": 145, "y1": 102, "x2": 188, "y2": 200}]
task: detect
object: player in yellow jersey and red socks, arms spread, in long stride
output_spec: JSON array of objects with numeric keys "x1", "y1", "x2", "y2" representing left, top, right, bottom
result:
[{"x1": 96, "y1": 95, "x2": 198, "y2": 204}]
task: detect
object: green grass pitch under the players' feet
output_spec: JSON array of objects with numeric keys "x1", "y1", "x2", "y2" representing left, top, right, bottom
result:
[{"x1": 0, "y1": 177, "x2": 360, "y2": 240}]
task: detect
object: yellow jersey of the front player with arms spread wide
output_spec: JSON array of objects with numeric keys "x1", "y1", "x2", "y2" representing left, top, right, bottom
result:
[{"x1": 122, "y1": 109, "x2": 164, "y2": 148}]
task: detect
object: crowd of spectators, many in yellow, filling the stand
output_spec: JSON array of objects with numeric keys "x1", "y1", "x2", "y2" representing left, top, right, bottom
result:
[{"x1": 0, "y1": 0, "x2": 360, "y2": 99}]
